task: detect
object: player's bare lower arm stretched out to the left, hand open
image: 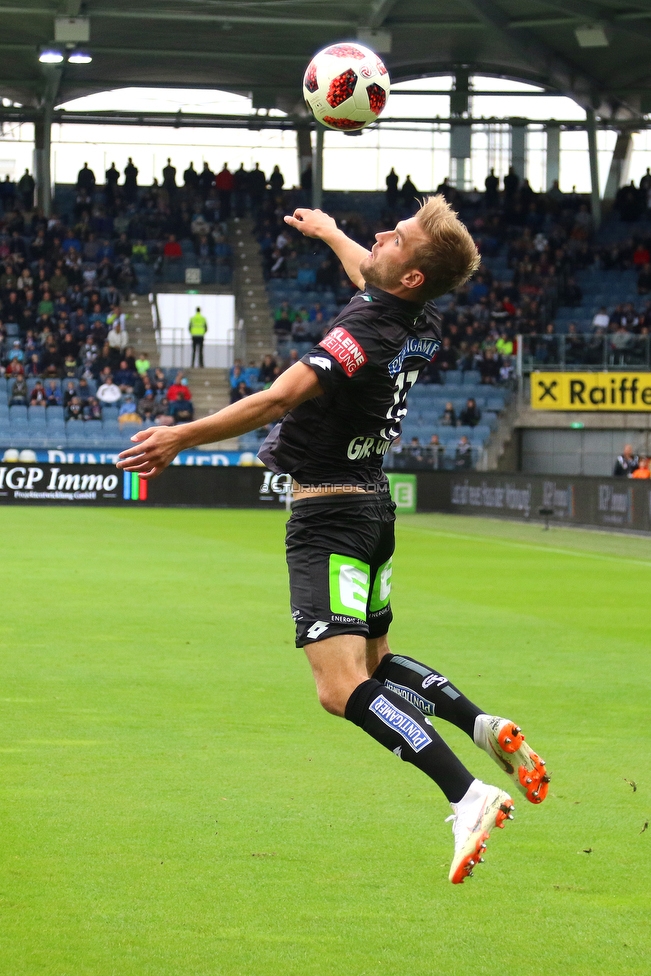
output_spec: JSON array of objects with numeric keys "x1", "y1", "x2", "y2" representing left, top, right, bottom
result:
[{"x1": 117, "y1": 363, "x2": 323, "y2": 478}]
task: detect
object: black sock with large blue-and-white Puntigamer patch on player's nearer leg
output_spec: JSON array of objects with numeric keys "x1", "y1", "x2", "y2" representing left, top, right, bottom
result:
[{"x1": 346, "y1": 678, "x2": 474, "y2": 803}]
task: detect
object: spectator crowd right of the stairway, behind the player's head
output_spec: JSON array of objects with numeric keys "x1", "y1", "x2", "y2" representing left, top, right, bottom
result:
[{"x1": 257, "y1": 162, "x2": 651, "y2": 376}]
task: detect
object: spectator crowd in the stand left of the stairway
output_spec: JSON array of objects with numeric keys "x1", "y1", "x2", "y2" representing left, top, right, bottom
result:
[{"x1": 0, "y1": 159, "x2": 304, "y2": 421}]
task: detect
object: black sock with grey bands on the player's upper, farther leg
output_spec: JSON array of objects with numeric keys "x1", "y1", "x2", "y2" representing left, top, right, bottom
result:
[{"x1": 373, "y1": 654, "x2": 484, "y2": 741}]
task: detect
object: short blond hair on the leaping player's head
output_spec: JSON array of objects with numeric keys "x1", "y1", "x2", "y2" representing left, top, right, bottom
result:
[{"x1": 415, "y1": 193, "x2": 481, "y2": 299}]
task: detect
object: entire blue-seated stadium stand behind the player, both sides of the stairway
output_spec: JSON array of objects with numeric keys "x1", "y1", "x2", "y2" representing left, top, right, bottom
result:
[{"x1": 0, "y1": 160, "x2": 651, "y2": 467}]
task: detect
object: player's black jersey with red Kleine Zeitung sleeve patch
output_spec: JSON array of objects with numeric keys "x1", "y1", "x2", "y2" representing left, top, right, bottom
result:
[{"x1": 258, "y1": 287, "x2": 441, "y2": 490}]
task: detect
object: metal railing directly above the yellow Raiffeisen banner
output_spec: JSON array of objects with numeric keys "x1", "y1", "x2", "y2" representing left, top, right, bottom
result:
[{"x1": 517, "y1": 332, "x2": 651, "y2": 375}]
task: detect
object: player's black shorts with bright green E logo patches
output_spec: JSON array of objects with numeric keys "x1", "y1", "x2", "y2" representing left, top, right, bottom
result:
[{"x1": 285, "y1": 493, "x2": 396, "y2": 647}]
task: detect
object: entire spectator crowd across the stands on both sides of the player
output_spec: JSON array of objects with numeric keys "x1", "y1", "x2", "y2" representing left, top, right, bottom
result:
[{"x1": 6, "y1": 152, "x2": 651, "y2": 456}]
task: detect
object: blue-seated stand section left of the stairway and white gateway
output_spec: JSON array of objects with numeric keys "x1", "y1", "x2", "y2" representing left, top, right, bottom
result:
[{"x1": 0, "y1": 166, "x2": 241, "y2": 451}]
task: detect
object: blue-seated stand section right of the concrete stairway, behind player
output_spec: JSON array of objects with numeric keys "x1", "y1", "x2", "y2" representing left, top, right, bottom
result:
[{"x1": 238, "y1": 177, "x2": 651, "y2": 467}]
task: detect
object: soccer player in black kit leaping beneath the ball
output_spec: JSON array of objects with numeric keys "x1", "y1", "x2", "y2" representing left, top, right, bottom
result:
[{"x1": 118, "y1": 196, "x2": 549, "y2": 884}]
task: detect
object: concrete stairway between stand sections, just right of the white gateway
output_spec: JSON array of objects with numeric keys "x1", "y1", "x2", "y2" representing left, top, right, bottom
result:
[{"x1": 230, "y1": 218, "x2": 275, "y2": 366}]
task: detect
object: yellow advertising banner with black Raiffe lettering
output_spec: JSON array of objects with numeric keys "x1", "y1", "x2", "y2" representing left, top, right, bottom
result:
[{"x1": 531, "y1": 372, "x2": 651, "y2": 413}]
